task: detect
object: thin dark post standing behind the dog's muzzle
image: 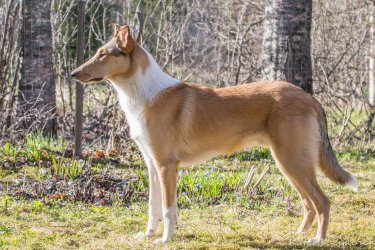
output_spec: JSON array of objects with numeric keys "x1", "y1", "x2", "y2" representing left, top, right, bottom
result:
[{"x1": 74, "y1": 0, "x2": 86, "y2": 157}]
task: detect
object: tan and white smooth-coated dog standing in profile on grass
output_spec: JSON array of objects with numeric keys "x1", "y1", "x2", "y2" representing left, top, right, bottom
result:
[{"x1": 71, "y1": 24, "x2": 358, "y2": 243}]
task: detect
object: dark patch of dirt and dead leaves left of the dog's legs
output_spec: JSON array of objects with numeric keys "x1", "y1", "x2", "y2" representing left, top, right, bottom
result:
[{"x1": 0, "y1": 169, "x2": 146, "y2": 205}]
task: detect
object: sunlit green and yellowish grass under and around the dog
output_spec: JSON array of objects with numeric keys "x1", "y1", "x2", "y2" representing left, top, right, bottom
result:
[{"x1": 0, "y1": 134, "x2": 375, "y2": 249}]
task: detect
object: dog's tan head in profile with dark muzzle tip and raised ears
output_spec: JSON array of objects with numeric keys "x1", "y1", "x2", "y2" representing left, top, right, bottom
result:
[{"x1": 71, "y1": 24, "x2": 144, "y2": 84}]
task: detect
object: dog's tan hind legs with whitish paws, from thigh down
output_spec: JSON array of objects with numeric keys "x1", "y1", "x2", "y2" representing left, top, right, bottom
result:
[{"x1": 271, "y1": 117, "x2": 330, "y2": 243}]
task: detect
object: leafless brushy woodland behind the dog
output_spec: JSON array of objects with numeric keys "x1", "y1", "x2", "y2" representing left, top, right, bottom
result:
[{"x1": 0, "y1": 0, "x2": 375, "y2": 150}]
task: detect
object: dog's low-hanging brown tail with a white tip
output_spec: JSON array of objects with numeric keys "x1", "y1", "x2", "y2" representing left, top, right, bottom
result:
[{"x1": 319, "y1": 109, "x2": 358, "y2": 192}]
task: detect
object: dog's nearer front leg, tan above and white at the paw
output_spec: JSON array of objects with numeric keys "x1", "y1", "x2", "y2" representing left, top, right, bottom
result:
[{"x1": 155, "y1": 163, "x2": 177, "y2": 243}]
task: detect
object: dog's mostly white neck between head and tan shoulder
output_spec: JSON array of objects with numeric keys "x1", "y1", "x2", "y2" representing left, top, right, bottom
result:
[{"x1": 111, "y1": 47, "x2": 180, "y2": 112}]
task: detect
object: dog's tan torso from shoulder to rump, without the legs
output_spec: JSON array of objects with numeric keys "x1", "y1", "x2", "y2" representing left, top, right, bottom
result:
[{"x1": 145, "y1": 81, "x2": 319, "y2": 163}]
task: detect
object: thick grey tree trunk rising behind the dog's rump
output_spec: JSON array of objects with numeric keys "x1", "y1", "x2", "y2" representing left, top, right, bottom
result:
[{"x1": 262, "y1": 0, "x2": 313, "y2": 94}]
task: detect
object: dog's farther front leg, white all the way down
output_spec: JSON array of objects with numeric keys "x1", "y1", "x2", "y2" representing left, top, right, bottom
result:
[{"x1": 136, "y1": 155, "x2": 163, "y2": 238}]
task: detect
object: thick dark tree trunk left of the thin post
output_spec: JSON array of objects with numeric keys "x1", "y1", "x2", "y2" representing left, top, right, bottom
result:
[{"x1": 17, "y1": 0, "x2": 56, "y2": 135}]
